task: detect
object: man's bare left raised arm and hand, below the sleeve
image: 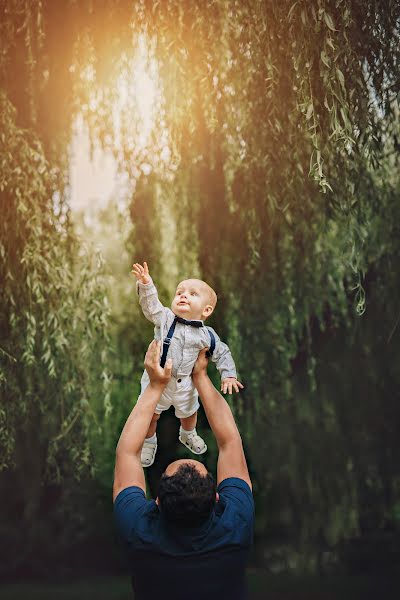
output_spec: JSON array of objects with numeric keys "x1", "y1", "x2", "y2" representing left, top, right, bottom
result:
[{"x1": 113, "y1": 340, "x2": 172, "y2": 500}]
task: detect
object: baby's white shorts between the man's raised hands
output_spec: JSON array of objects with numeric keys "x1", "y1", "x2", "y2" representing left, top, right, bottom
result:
[{"x1": 140, "y1": 371, "x2": 200, "y2": 419}]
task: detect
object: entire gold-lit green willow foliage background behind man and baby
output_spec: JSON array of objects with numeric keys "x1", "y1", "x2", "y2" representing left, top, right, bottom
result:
[{"x1": 0, "y1": 0, "x2": 400, "y2": 576}]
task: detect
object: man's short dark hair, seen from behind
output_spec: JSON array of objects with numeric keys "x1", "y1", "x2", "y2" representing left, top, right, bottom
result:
[{"x1": 158, "y1": 464, "x2": 216, "y2": 527}]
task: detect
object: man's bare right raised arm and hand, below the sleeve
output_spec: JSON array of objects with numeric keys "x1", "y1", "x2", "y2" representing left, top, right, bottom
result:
[{"x1": 192, "y1": 350, "x2": 251, "y2": 488}]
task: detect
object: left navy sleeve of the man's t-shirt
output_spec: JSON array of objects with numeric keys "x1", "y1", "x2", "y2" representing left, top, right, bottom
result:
[{"x1": 114, "y1": 486, "x2": 149, "y2": 542}]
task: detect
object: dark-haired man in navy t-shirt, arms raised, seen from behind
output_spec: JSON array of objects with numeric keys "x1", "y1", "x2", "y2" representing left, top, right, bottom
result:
[{"x1": 114, "y1": 341, "x2": 254, "y2": 600}]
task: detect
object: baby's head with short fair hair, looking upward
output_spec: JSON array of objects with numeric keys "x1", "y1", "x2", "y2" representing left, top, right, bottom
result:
[{"x1": 171, "y1": 279, "x2": 217, "y2": 321}]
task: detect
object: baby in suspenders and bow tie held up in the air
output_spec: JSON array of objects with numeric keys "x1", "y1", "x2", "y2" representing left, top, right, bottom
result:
[{"x1": 132, "y1": 263, "x2": 243, "y2": 467}]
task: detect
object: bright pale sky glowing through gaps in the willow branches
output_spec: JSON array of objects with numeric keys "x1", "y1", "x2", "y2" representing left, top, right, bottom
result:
[{"x1": 70, "y1": 35, "x2": 162, "y2": 212}]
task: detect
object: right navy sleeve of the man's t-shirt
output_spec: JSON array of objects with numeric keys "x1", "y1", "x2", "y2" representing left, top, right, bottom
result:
[{"x1": 217, "y1": 477, "x2": 254, "y2": 545}]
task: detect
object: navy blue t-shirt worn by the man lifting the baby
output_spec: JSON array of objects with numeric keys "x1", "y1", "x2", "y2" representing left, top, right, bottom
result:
[{"x1": 114, "y1": 477, "x2": 254, "y2": 600}]
